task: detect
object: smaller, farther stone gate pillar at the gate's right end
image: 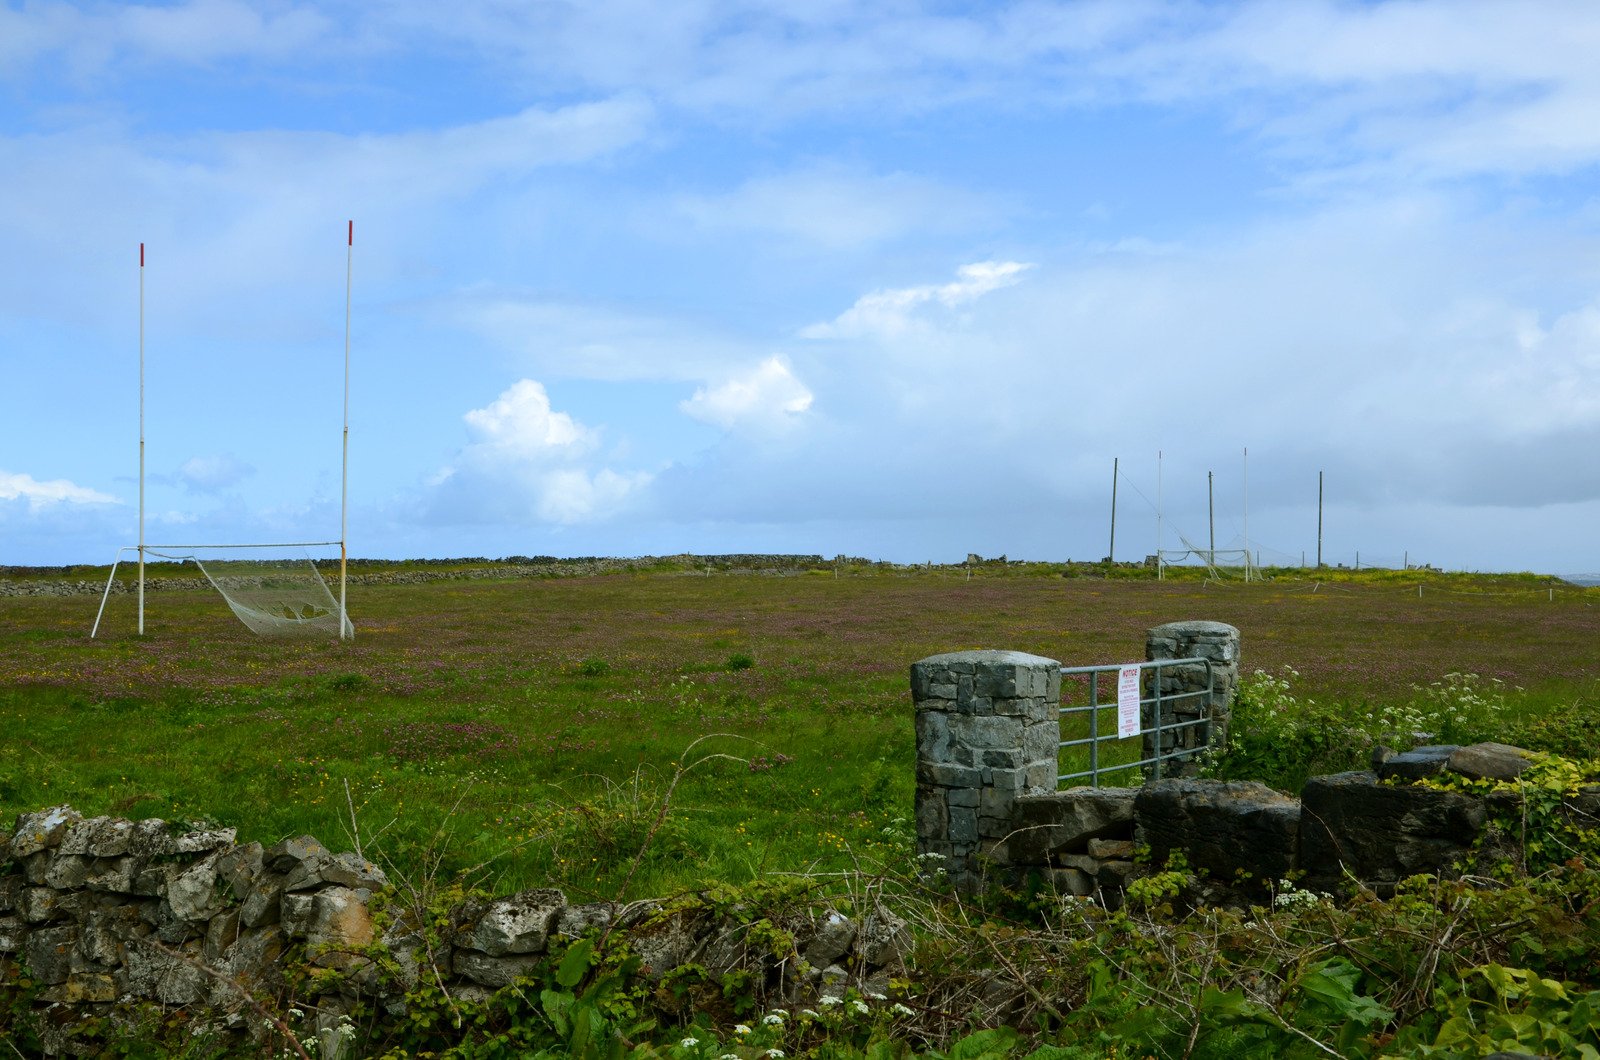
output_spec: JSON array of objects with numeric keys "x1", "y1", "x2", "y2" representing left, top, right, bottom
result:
[{"x1": 1139, "y1": 620, "x2": 1238, "y2": 777}]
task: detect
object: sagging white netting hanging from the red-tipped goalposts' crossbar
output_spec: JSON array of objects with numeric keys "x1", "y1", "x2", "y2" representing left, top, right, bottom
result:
[{"x1": 144, "y1": 544, "x2": 355, "y2": 637}]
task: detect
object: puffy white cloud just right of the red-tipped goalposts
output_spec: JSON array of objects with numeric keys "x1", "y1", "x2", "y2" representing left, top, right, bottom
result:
[{"x1": 429, "y1": 379, "x2": 651, "y2": 525}]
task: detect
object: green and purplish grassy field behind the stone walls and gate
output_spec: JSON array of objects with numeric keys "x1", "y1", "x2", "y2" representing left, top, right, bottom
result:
[{"x1": 0, "y1": 565, "x2": 1600, "y2": 898}]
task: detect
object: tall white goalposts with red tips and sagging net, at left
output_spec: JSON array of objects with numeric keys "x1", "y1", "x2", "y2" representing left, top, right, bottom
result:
[{"x1": 90, "y1": 221, "x2": 355, "y2": 640}]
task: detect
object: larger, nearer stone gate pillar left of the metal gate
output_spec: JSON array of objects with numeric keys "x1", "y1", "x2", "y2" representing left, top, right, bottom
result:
[{"x1": 910, "y1": 652, "x2": 1061, "y2": 890}]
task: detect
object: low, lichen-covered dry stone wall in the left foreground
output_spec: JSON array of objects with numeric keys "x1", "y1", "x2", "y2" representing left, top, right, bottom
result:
[{"x1": 0, "y1": 805, "x2": 909, "y2": 1057}]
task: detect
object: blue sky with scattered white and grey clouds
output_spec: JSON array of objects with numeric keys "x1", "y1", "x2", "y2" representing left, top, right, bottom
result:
[{"x1": 0, "y1": 0, "x2": 1600, "y2": 573}]
